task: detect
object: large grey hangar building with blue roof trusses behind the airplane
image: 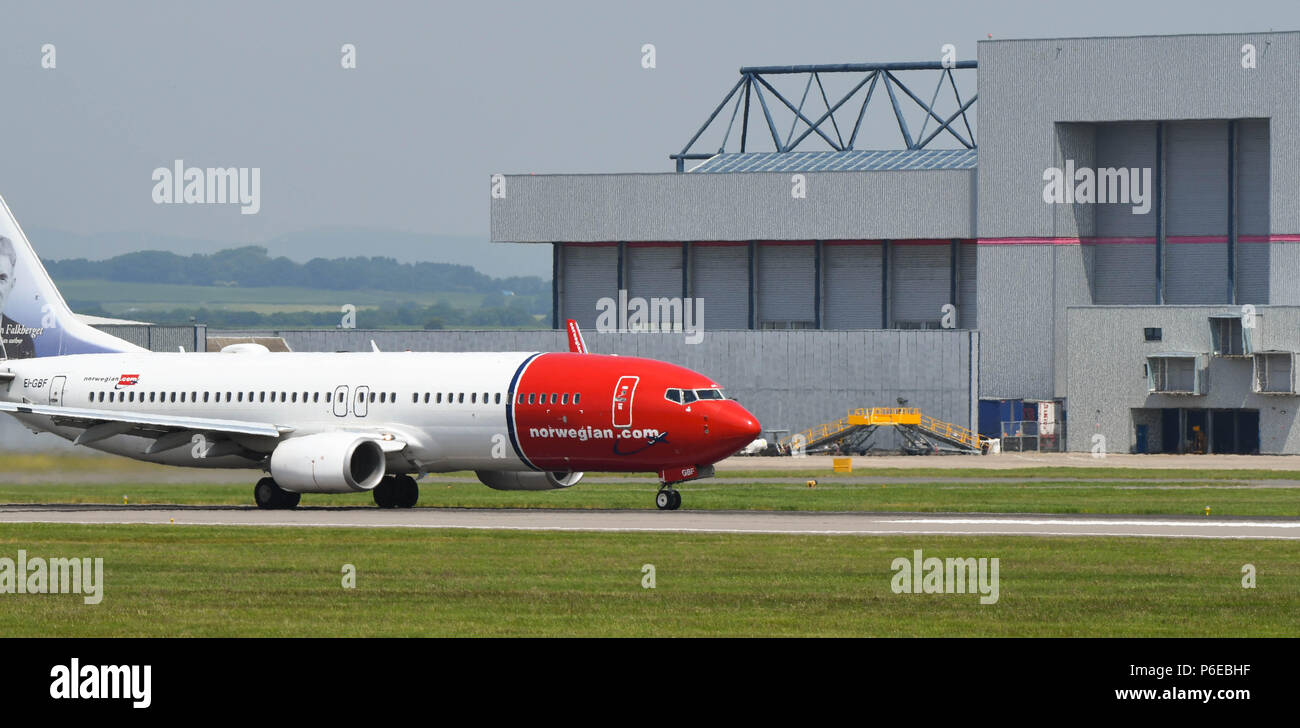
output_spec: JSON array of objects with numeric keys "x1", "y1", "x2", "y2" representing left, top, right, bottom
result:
[{"x1": 480, "y1": 33, "x2": 1300, "y2": 454}]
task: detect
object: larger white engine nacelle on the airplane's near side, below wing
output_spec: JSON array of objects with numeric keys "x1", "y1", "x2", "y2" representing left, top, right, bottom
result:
[{"x1": 270, "y1": 432, "x2": 387, "y2": 493}]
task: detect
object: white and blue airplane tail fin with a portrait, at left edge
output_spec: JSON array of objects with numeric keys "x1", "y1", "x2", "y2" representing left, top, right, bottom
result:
[{"x1": 0, "y1": 198, "x2": 144, "y2": 359}]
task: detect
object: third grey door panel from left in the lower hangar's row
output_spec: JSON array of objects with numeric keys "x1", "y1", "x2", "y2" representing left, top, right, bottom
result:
[{"x1": 690, "y1": 243, "x2": 749, "y2": 330}]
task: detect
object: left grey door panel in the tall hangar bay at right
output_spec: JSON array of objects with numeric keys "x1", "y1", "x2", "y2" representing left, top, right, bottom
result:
[{"x1": 1092, "y1": 124, "x2": 1157, "y2": 304}]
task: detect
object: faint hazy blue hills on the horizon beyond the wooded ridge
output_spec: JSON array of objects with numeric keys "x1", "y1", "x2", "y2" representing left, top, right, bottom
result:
[{"x1": 27, "y1": 228, "x2": 551, "y2": 280}]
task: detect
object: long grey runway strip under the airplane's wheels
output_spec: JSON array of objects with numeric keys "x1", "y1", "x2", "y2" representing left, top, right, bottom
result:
[{"x1": 0, "y1": 504, "x2": 1300, "y2": 541}]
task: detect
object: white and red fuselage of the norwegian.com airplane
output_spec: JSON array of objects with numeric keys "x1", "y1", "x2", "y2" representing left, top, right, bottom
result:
[{"x1": 0, "y1": 352, "x2": 758, "y2": 473}]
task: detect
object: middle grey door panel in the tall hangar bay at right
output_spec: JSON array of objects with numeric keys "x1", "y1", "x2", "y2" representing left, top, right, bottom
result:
[{"x1": 1165, "y1": 121, "x2": 1229, "y2": 303}]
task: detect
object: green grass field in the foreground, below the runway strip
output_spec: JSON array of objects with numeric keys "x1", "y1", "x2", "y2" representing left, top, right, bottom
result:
[{"x1": 0, "y1": 524, "x2": 1300, "y2": 637}]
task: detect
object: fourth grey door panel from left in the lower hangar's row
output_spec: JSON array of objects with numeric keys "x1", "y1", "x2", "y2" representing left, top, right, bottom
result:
[{"x1": 758, "y1": 243, "x2": 816, "y2": 329}]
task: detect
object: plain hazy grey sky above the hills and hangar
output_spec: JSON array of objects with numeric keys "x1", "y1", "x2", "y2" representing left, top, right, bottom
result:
[{"x1": 0, "y1": 0, "x2": 1300, "y2": 277}]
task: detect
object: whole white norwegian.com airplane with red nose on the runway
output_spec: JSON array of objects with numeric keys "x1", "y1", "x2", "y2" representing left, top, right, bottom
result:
[{"x1": 0, "y1": 199, "x2": 759, "y2": 510}]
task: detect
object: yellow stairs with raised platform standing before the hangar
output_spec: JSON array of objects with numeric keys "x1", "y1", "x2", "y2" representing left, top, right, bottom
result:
[{"x1": 780, "y1": 407, "x2": 988, "y2": 454}]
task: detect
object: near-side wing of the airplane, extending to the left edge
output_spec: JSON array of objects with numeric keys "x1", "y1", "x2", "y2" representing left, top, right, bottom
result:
[{"x1": 0, "y1": 402, "x2": 294, "y2": 452}]
